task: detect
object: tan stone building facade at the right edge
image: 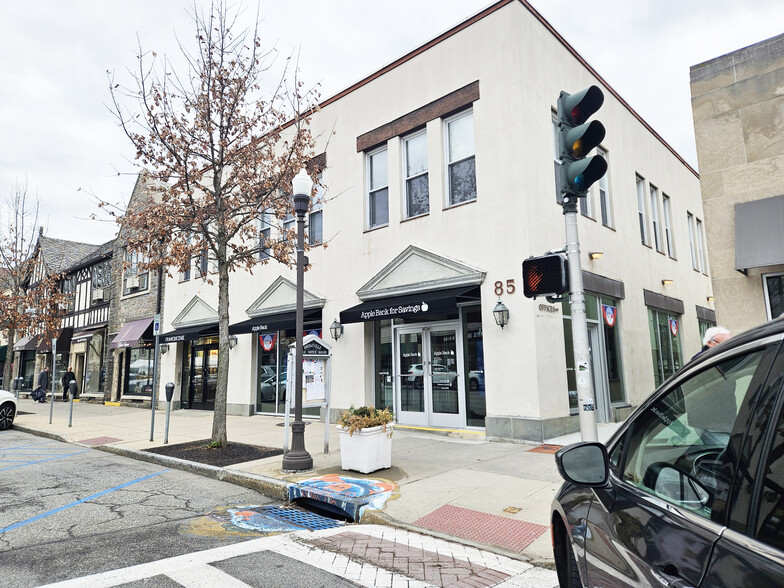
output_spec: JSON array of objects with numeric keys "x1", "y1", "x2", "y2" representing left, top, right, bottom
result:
[{"x1": 691, "y1": 35, "x2": 784, "y2": 332}]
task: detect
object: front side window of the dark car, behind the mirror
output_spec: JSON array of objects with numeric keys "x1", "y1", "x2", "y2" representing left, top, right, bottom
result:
[{"x1": 623, "y1": 351, "x2": 763, "y2": 518}]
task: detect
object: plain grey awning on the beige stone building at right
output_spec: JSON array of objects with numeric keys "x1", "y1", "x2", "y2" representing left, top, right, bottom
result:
[{"x1": 735, "y1": 196, "x2": 784, "y2": 272}]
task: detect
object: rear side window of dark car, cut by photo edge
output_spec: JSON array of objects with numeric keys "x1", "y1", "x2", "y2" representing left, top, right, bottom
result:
[{"x1": 754, "y1": 398, "x2": 784, "y2": 550}]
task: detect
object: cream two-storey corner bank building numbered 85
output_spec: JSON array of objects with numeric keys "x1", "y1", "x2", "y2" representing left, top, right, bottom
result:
[{"x1": 155, "y1": 0, "x2": 715, "y2": 441}]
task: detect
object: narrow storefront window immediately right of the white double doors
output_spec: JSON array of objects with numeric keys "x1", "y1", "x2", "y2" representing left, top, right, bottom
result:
[{"x1": 463, "y1": 306, "x2": 487, "y2": 427}]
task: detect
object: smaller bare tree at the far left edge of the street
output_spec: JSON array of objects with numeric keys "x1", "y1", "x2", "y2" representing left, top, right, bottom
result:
[{"x1": 0, "y1": 180, "x2": 66, "y2": 388}]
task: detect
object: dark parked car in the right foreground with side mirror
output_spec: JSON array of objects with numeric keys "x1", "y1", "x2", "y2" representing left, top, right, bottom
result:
[{"x1": 551, "y1": 319, "x2": 784, "y2": 586}]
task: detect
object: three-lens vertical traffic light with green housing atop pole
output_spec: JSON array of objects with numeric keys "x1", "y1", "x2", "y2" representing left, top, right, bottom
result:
[{"x1": 558, "y1": 86, "x2": 607, "y2": 204}]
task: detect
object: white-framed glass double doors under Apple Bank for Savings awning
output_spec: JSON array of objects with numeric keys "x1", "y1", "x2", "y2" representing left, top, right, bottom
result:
[{"x1": 395, "y1": 324, "x2": 465, "y2": 427}]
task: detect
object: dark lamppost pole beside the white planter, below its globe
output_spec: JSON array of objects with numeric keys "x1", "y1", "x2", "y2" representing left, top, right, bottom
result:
[{"x1": 283, "y1": 209, "x2": 313, "y2": 471}]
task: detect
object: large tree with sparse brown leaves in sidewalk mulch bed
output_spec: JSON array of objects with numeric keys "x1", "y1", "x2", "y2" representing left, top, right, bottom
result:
[{"x1": 110, "y1": 0, "x2": 318, "y2": 446}]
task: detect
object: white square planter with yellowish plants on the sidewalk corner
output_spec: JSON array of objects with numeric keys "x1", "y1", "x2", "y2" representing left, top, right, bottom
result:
[{"x1": 337, "y1": 406, "x2": 394, "y2": 474}]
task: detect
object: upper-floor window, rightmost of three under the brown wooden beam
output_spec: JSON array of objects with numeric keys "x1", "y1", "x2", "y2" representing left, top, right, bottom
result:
[{"x1": 445, "y1": 110, "x2": 476, "y2": 206}]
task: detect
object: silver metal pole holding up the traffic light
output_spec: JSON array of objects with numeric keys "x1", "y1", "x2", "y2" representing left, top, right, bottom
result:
[{"x1": 563, "y1": 204, "x2": 599, "y2": 441}]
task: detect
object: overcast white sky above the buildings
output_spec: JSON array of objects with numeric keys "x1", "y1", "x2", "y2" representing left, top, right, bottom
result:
[{"x1": 0, "y1": 0, "x2": 784, "y2": 243}]
